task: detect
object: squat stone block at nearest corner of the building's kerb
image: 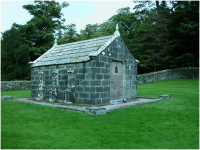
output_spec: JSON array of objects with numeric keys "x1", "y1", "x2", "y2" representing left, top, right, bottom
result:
[{"x1": 85, "y1": 107, "x2": 106, "y2": 116}]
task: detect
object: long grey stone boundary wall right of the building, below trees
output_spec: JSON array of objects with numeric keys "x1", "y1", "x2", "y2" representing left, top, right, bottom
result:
[{"x1": 137, "y1": 67, "x2": 199, "y2": 84}]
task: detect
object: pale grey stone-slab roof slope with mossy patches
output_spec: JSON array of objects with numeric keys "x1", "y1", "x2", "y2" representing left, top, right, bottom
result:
[{"x1": 30, "y1": 35, "x2": 119, "y2": 67}]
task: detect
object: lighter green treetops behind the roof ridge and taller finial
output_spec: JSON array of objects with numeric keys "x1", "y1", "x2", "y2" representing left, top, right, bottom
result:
[{"x1": 77, "y1": 7, "x2": 140, "y2": 50}]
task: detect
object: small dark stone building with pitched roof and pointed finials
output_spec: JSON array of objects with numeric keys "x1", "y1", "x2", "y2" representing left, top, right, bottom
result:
[{"x1": 30, "y1": 25, "x2": 139, "y2": 106}]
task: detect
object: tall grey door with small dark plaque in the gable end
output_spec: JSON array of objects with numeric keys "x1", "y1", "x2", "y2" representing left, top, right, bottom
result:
[{"x1": 110, "y1": 62, "x2": 123, "y2": 101}]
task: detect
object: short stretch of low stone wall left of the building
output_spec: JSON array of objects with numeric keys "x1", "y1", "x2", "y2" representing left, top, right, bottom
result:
[{"x1": 1, "y1": 81, "x2": 31, "y2": 91}]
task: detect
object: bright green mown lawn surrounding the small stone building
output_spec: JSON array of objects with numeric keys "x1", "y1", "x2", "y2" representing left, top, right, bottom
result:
[{"x1": 1, "y1": 79, "x2": 199, "y2": 149}]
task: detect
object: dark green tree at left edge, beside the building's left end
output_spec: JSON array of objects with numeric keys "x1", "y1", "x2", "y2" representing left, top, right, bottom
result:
[{"x1": 1, "y1": 23, "x2": 30, "y2": 81}]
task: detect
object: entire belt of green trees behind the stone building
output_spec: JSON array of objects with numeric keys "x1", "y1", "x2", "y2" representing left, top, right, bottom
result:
[{"x1": 1, "y1": 0, "x2": 199, "y2": 80}]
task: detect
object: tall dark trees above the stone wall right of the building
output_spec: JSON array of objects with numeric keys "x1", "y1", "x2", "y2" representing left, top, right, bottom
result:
[{"x1": 133, "y1": 1, "x2": 199, "y2": 73}]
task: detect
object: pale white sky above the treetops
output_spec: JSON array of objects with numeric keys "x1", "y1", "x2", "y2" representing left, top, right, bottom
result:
[{"x1": 0, "y1": 0, "x2": 135, "y2": 32}]
